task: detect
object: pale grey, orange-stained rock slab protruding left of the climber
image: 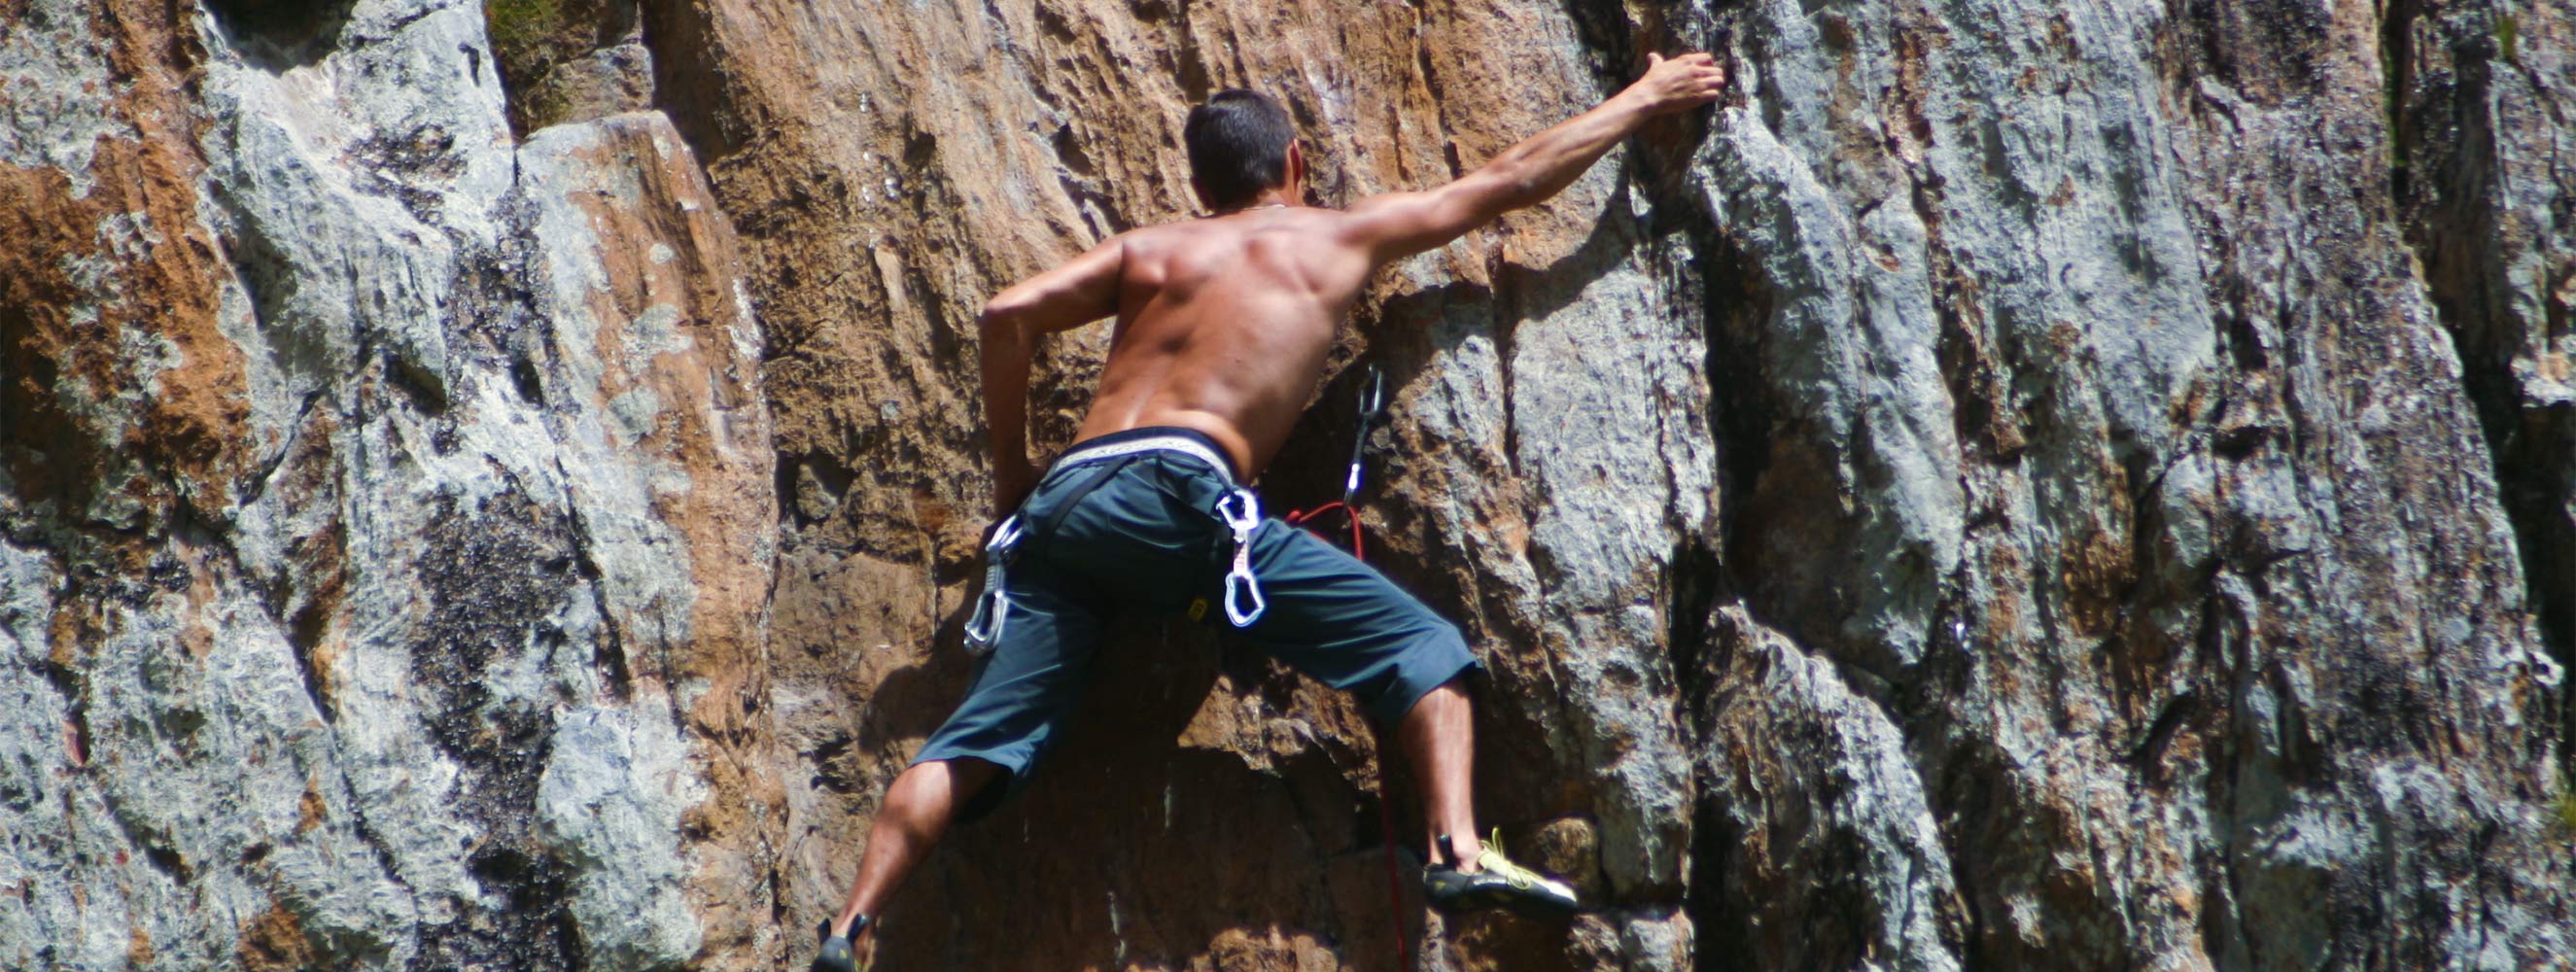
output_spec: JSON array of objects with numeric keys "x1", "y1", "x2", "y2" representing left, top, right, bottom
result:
[{"x1": 0, "y1": 3, "x2": 781, "y2": 969}]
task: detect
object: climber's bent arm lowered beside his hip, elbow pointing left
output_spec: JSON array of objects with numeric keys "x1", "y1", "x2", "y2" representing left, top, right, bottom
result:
[{"x1": 976, "y1": 237, "x2": 1126, "y2": 516}]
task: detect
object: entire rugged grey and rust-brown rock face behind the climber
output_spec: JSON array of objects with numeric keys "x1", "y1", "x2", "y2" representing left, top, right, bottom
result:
[{"x1": 0, "y1": 0, "x2": 2576, "y2": 969}]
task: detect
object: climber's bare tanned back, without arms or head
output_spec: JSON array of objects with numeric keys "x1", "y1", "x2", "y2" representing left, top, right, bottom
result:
[{"x1": 1074, "y1": 206, "x2": 1375, "y2": 477}]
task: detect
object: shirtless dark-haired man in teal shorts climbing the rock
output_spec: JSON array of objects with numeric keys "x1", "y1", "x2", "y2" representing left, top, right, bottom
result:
[{"x1": 814, "y1": 54, "x2": 1726, "y2": 969}]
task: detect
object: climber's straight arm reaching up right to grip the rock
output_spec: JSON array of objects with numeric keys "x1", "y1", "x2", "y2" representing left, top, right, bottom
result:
[{"x1": 1350, "y1": 54, "x2": 1726, "y2": 263}]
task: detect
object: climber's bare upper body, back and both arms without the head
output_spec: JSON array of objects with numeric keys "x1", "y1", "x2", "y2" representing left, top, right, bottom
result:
[{"x1": 979, "y1": 54, "x2": 1726, "y2": 503}]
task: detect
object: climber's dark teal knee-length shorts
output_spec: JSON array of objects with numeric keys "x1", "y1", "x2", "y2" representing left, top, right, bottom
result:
[{"x1": 915, "y1": 428, "x2": 1476, "y2": 820}]
